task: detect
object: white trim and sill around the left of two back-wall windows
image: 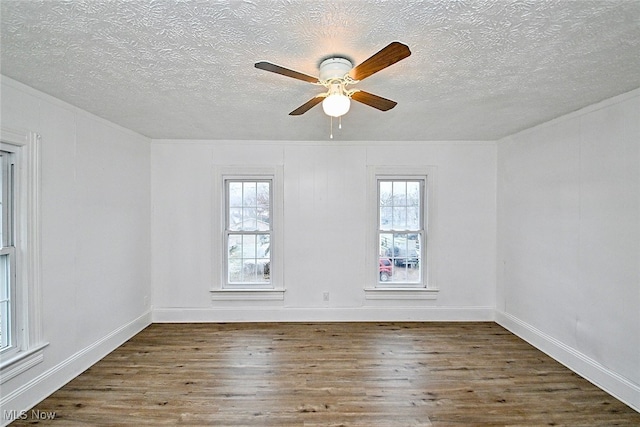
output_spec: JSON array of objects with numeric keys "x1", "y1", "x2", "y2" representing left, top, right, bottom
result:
[{"x1": 210, "y1": 165, "x2": 285, "y2": 301}]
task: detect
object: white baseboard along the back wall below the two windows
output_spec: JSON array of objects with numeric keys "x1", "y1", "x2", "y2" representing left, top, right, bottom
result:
[{"x1": 153, "y1": 307, "x2": 494, "y2": 323}]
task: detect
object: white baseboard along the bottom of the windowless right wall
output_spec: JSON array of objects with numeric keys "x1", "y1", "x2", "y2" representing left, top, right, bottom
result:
[{"x1": 495, "y1": 311, "x2": 640, "y2": 412}]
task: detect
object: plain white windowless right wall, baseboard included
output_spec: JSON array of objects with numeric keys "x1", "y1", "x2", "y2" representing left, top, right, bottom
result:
[{"x1": 496, "y1": 90, "x2": 640, "y2": 410}]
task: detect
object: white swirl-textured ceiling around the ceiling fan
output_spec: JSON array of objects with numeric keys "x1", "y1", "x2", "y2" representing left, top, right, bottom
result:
[{"x1": 0, "y1": 0, "x2": 640, "y2": 141}]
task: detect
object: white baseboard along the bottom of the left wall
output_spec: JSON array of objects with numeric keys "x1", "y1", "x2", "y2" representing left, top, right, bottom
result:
[{"x1": 0, "y1": 311, "x2": 151, "y2": 426}]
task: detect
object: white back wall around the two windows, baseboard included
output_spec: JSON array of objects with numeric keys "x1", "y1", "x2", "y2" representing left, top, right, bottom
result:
[{"x1": 151, "y1": 140, "x2": 496, "y2": 321}]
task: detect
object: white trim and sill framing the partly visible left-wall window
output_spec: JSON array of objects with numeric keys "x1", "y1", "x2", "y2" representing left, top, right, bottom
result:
[{"x1": 0, "y1": 127, "x2": 48, "y2": 384}]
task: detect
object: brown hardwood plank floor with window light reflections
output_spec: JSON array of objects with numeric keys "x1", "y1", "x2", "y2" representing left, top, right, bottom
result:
[{"x1": 14, "y1": 323, "x2": 640, "y2": 427}]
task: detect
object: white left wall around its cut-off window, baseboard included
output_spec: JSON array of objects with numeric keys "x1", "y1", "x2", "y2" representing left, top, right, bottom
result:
[{"x1": 0, "y1": 77, "x2": 151, "y2": 421}]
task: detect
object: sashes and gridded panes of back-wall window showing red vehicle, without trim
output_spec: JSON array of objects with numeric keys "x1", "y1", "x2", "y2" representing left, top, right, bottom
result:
[{"x1": 377, "y1": 178, "x2": 425, "y2": 287}]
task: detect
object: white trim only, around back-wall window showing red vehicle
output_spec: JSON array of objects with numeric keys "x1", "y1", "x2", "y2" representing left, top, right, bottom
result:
[{"x1": 364, "y1": 165, "x2": 438, "y2": 300}]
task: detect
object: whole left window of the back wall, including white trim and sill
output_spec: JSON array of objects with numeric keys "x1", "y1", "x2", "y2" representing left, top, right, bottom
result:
[{"x1": 211, "y1": 166, "x2": 284, "y2": 304}]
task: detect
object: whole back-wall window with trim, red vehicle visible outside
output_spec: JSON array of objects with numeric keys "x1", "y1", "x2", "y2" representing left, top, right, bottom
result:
[{"x1": 365, "y1": 166, "x2": 437, "y2": 299}]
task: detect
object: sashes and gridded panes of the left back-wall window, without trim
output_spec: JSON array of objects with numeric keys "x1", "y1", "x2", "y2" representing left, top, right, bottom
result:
[{"x1": 225, "y1": 179, "x2": 273, "y2": 288}]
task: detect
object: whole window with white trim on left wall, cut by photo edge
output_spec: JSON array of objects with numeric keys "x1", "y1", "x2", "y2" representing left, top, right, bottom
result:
[{"x1": 0, "y1": 128, "x2": 47, "y2": 383}]
